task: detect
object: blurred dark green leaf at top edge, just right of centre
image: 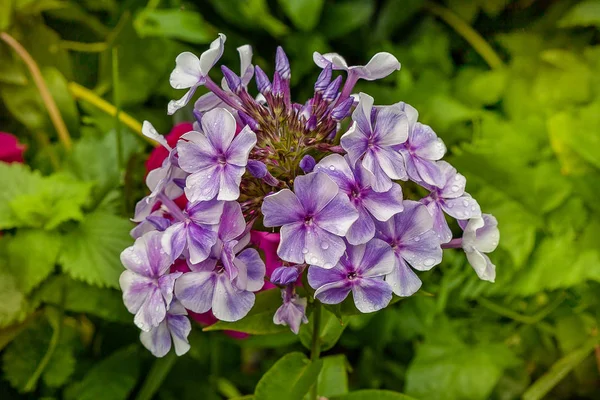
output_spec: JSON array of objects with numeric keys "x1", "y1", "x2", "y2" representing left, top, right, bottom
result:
[{"x1": 320, "y1": 0, "x2": 375, "y2": 39}]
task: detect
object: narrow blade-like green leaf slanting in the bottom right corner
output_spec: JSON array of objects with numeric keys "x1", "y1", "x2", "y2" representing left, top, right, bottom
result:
[{"x1": 523, "y1": 338, "x2": 598, "y2": 400}]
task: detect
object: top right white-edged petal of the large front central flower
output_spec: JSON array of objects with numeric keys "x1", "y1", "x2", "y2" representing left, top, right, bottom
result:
[{"x1": 294, "y1": 173, "x2": 339, "y2": 215}]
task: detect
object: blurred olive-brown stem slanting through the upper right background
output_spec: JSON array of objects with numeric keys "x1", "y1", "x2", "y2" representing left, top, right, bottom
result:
[{"x1": 425, "y1": 1, "x2": 504, "y2": 69}]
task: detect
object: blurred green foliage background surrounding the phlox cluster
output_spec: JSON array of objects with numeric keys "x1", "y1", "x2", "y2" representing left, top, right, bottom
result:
[{"x1": 0, "y1": 0, "x2": 600, "y2": 400}]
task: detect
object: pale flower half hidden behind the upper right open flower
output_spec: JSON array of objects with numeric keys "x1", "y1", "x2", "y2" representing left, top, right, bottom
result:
[{"x1": 398, "y1": 103, "x2": 446, "y2": 186}]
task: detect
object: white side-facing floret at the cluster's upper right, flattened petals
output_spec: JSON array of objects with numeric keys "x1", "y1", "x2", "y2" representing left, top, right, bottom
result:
[{"x1": 313, "y1": 51, "x2": 400, "y2": 81}]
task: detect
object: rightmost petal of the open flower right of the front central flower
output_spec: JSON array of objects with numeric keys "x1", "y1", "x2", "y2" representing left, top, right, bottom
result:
[{"x1": 399, "y1": 230, "x2": 442, "y2": 271}]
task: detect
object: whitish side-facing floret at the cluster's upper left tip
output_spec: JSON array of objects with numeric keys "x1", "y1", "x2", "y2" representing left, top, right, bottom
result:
[{"x1": 167, "y1": 33, "x2": 227, "y2": 115}]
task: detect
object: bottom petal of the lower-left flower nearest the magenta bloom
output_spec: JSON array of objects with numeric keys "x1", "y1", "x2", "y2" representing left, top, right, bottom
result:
[{"x1": 212, "y1": 274, "x2": 255, "y2": 322}]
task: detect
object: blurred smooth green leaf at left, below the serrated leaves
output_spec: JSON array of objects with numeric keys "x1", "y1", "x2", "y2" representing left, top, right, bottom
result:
[{"x1": 6, "y1": 229, "x2": 62, "y2": 294}]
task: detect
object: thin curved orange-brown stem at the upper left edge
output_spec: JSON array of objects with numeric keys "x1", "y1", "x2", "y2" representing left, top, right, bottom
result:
[{"x1": 0, "y1": 32, "x2": 73, "y2": 151}]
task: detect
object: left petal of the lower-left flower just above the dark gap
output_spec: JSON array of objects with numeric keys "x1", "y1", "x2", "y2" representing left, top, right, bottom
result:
[{"x1": 175, "y1": 271, "x2": 217, "y2": 313}]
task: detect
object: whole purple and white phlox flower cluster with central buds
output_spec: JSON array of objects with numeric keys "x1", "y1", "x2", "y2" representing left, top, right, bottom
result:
[{"x1": 120, "y1": 34, "x2": 499, "y2": 357}]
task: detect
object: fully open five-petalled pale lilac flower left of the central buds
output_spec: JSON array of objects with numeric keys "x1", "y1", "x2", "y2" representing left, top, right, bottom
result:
[{"x1": 177, "y1": 108, "x2": 256, "y2": 202}]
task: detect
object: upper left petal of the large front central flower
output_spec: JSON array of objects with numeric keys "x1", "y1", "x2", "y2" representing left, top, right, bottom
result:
[{"x1": 261, "y1": 189, "x2": 304, "y2": 227}]
